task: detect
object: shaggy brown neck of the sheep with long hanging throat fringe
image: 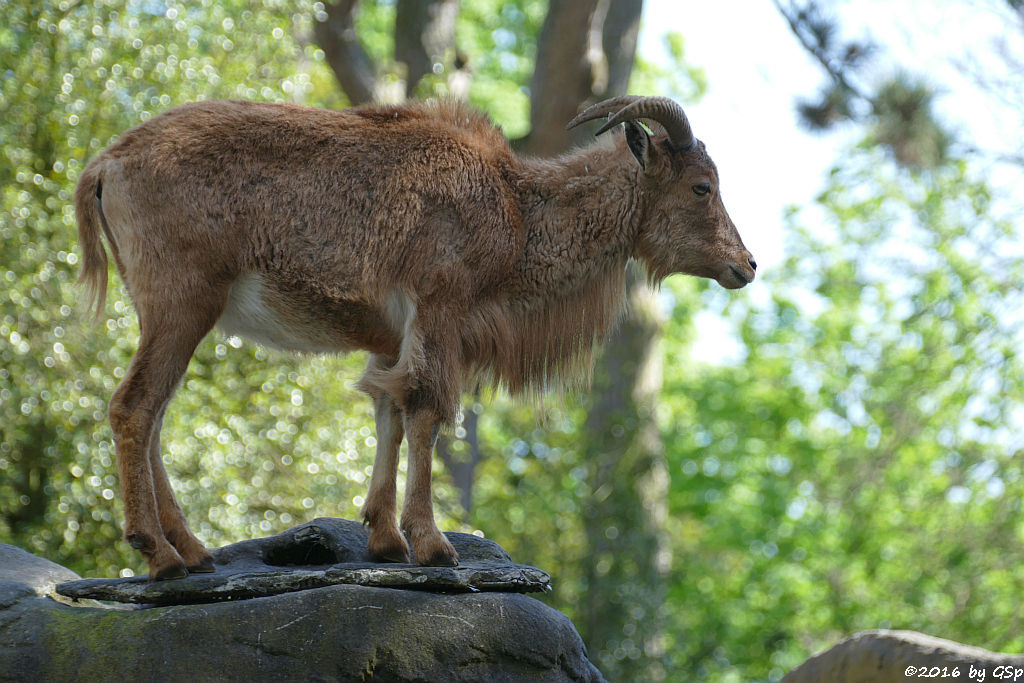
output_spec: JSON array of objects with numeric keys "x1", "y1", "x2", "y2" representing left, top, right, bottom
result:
[{"x1": 464, "y1": 147, "x2": 639, "y2": 394}]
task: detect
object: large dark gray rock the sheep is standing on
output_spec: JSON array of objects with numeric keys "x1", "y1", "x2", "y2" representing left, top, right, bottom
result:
[{"x1": 0, "y1": 519, "x2": 603, "y2": 682}]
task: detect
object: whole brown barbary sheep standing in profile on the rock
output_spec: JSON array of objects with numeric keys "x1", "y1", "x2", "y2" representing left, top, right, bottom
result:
[{"x1": 75, "y1": 96, "x2": 756, "y2": 580}]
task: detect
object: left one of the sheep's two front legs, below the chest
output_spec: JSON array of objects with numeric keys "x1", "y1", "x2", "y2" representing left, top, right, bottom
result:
[{"x1": 362, "y1": 376, "x2": 410, "y2": 563}]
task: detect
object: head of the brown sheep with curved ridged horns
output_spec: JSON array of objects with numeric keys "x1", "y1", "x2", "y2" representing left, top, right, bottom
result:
[{"x1": 567, "y1": 95, "x2": 757, "y2": 289}]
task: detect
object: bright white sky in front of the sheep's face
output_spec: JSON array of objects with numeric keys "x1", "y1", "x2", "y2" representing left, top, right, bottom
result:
[{"x1": 640, "y1": 0, "x2": 1024, "y2": 361}]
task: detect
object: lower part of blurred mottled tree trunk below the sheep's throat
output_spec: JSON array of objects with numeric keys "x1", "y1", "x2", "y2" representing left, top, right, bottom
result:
[{"x1": 580, "y1": 267, "x2": 671, "y2": 681}]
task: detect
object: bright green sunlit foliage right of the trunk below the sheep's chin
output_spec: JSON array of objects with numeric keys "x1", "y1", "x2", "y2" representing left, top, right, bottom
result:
[{"x1": 665, "y1": 151, "x2": 1024, "y2": 681}]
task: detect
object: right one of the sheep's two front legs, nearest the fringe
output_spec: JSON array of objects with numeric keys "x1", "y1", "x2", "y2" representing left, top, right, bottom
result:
[{"x1": 401, "y1": 410, "x2": 459, "y2": 566}]
